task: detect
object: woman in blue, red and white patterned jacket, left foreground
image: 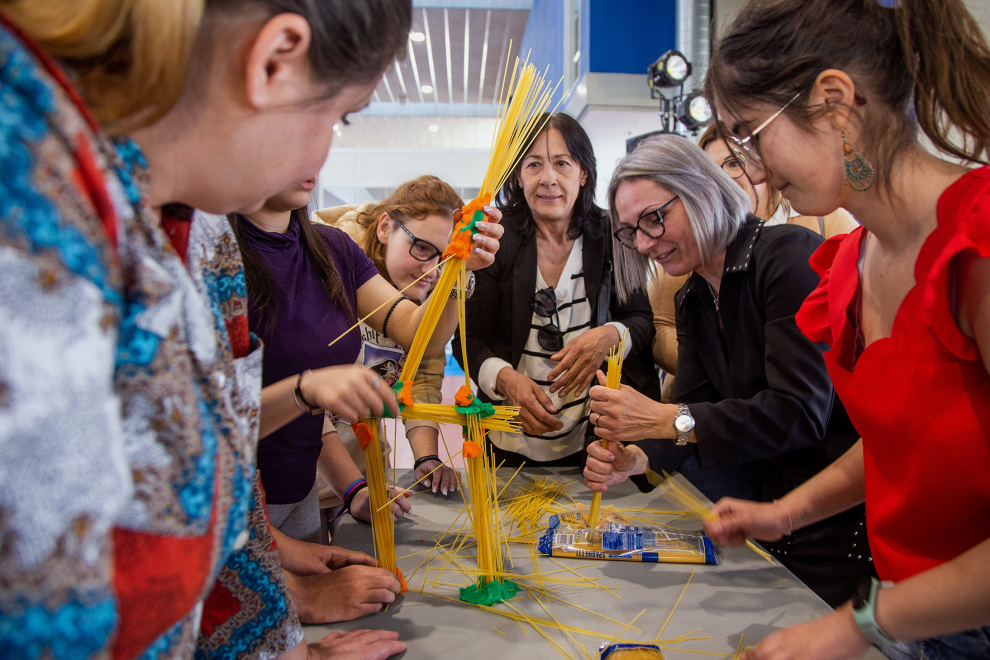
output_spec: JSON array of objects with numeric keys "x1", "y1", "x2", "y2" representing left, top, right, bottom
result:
[{"x1": 0, "y1": 0, "x2": 420, "y2": 659}]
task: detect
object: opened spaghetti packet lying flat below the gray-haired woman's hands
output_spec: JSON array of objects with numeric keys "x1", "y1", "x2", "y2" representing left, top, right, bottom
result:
[{"x1": 538, "y1": 511, "x2": 722, "y2": 564}]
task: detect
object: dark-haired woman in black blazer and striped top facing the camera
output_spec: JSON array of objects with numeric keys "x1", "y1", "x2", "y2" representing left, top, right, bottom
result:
[{"x1": 454, "y1": 114, "x2": 659, "y2": 465}]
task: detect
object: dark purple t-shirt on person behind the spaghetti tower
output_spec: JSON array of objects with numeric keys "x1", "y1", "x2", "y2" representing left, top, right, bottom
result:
[{"x1": 241, "y1": 219, "x2": 378, "y2": 504}]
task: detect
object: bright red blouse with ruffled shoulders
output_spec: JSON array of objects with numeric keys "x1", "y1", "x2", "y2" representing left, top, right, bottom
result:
[{"x1": 797, "y1": 167, "x2": 990, "y2": 580}]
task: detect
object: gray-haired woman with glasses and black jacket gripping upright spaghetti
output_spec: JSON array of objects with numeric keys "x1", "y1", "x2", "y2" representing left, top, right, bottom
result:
[{"x1": 584, "y1": 135, "x2": 873, "y2": 606}]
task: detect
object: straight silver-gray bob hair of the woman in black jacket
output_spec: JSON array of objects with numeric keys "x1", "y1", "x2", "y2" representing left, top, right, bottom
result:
[{"x1": 608, "y1": 134, "x2": 752, "y2": 302}]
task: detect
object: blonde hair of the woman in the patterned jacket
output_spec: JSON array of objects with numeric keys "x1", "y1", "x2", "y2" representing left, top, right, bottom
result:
[{"x1": 0, "y1": 0, "x2": 206, "y2": 133}]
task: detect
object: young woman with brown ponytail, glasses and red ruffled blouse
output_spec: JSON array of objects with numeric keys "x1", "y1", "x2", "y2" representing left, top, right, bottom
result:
[{"x1": 706, "y1": 0, "x2": 990, "y2": 659}]
